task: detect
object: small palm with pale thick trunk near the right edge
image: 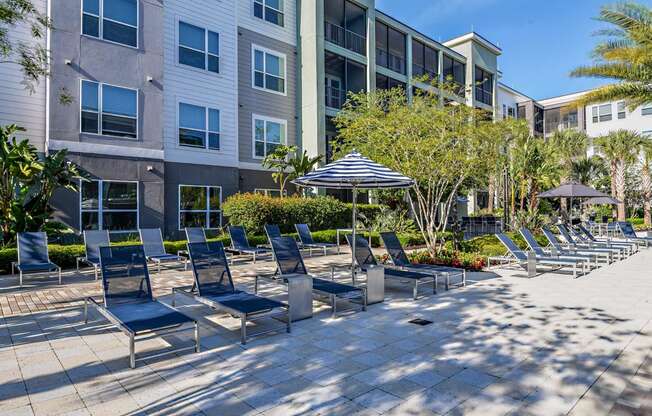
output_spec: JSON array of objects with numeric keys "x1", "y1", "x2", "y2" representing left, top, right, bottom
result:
[{"x1": 595, "y1": 130, "x2": 645, "y2": 221}]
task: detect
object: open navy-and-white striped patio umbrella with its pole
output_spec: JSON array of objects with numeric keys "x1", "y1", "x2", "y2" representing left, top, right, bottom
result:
[{"x1": 292, "y1": 150, "x2": 415, "y2": 280}]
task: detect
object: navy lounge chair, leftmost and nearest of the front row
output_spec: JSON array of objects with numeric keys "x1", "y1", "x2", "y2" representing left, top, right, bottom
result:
[{"x1": 84, "y1": 245, "x2": 199, "y2": 368}]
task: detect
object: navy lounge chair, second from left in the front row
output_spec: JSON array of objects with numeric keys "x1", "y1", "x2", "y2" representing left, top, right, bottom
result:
[{"x1": 172, "y1": 241, "x2": 291, "y2": 345}]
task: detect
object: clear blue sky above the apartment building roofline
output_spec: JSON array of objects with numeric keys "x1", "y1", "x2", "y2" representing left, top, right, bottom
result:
[{"x1": 376, "y1": 0, "x2": 652, "y2": 99}]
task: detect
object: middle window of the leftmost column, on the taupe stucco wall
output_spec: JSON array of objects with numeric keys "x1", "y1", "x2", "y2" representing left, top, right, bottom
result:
[{"x1": 81, "y1": 80, "x2": 138, "y2": 139}]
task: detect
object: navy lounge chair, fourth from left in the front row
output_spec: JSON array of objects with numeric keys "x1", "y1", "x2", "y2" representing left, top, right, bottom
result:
[{"x1": 346, "y1": 234, "x2": 443, "y2": 300}]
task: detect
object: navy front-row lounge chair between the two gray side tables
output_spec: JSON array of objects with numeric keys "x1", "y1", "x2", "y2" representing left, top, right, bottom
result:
[{"x1": 255, "y1": 237, "x2": 367, "y2": 316}]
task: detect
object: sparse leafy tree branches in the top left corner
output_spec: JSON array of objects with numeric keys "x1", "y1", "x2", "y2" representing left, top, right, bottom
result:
[{"x1": 0, "y1": 0, "x2": 51, "y2": 91}]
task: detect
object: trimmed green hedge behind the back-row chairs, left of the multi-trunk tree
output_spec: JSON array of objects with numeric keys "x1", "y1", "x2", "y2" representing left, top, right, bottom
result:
[{"x1": 222, "y1": 193, "x2": 380, "y2": 234}]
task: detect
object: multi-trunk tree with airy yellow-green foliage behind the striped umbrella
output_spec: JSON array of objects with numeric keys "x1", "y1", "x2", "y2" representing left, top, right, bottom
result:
[{"x1": 335, "y1": 88, "x2": 502, "y2": 253}]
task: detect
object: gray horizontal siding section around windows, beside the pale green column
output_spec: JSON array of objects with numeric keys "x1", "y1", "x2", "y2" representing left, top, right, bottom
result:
[{"x1": 238, "y1": 27, "x2": 297, "y2": 163}]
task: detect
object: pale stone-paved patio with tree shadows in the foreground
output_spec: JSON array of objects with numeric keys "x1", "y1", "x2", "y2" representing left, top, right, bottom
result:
[{"x1": 0, "y1": 249, "x2": 652, "y2": 416}]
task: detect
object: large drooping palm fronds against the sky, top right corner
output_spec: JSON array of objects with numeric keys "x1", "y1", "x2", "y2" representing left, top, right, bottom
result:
[{"x1": 571, "y1": 3, "x2": 652, "y2": 109}]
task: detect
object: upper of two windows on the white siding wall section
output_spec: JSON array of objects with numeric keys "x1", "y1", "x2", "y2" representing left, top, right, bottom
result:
[{"x1": 179, "y1": 22, "x2": 220, "y2": 74}]
